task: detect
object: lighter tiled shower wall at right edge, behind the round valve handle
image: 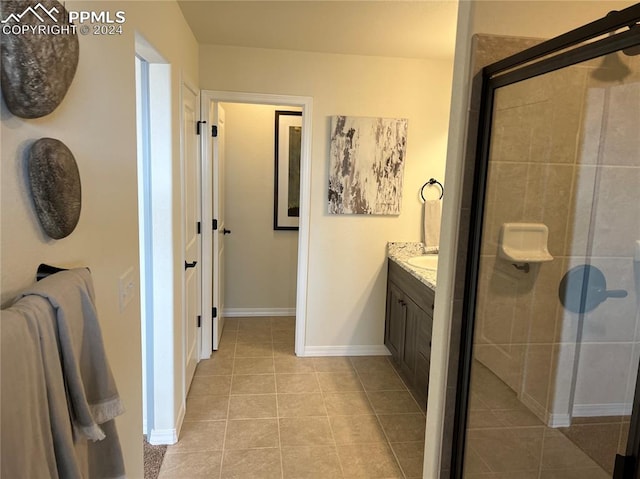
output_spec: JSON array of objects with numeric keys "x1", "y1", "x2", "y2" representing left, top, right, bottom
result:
[{"x1": 557, "y1": 63, "x2": 640, "y2": 416}]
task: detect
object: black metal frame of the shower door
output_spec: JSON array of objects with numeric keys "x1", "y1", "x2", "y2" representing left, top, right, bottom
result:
[{"x1": 450, "y1": 4, "x2": 640, "y2": 479}]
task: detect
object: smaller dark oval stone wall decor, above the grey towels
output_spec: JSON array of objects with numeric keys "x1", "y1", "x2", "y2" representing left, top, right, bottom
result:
[{"x1": 28, "y1": 138, "x2": 82, "y2": 239}]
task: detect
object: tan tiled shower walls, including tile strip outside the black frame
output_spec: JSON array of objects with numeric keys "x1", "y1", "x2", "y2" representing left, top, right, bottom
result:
[{"x1": 441, "y1": 35, "x2": 640, "y2": 477}]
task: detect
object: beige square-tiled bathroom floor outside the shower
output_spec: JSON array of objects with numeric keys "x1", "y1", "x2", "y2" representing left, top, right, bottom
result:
[{"x1": 159, "y1": 317, "x2": 425, "y2": 479}]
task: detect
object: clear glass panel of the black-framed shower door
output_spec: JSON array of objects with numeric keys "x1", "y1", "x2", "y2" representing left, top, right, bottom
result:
[{"x1": 462, "y1": 44, "x2": 640, "y2": 479}]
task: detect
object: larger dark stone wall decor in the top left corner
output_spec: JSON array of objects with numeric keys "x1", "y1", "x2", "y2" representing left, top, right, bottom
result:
[{"x1": 0, "y1": 0, "x2": 80, "y2": 118}]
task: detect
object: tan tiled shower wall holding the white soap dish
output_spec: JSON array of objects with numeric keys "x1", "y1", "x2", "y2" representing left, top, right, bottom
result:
[{"x1": 475, "y1": 63, "x2": 584, "y2": 422}]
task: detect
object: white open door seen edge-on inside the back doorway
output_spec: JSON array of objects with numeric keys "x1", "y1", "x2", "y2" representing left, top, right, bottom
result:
[{"x1": 209, "y1": 102, "x2": 230, "y2": 350}]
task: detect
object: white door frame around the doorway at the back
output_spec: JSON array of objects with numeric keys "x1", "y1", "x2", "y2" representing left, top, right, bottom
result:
[{"x1": 200, "y1": 90, "x2": 313, "y2": 359}]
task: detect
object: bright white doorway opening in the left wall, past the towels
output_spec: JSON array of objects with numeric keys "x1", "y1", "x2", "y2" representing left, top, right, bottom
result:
[{"x1": 135, "y1": 35, "x2": 177, "y2": 444}]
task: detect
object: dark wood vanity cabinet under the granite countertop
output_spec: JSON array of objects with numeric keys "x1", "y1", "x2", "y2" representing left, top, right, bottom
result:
[{"x1": 384, "y1": 260, "x2": 435, "y2": 409}]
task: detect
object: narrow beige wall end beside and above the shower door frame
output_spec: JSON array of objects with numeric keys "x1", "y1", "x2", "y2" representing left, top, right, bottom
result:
[{"x1": 424, "y1": 1, "x2": 633, "y2": 478}]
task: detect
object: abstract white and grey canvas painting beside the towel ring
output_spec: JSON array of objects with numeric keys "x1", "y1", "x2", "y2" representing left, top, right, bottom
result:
[{"x1": 329, "y1": 116, "x2": 408, "y2": 215}]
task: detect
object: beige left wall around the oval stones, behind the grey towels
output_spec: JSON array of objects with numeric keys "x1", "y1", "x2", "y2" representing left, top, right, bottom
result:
[{"x1": 1, "y1": 2, "x2": 198, "y2": 477}]
